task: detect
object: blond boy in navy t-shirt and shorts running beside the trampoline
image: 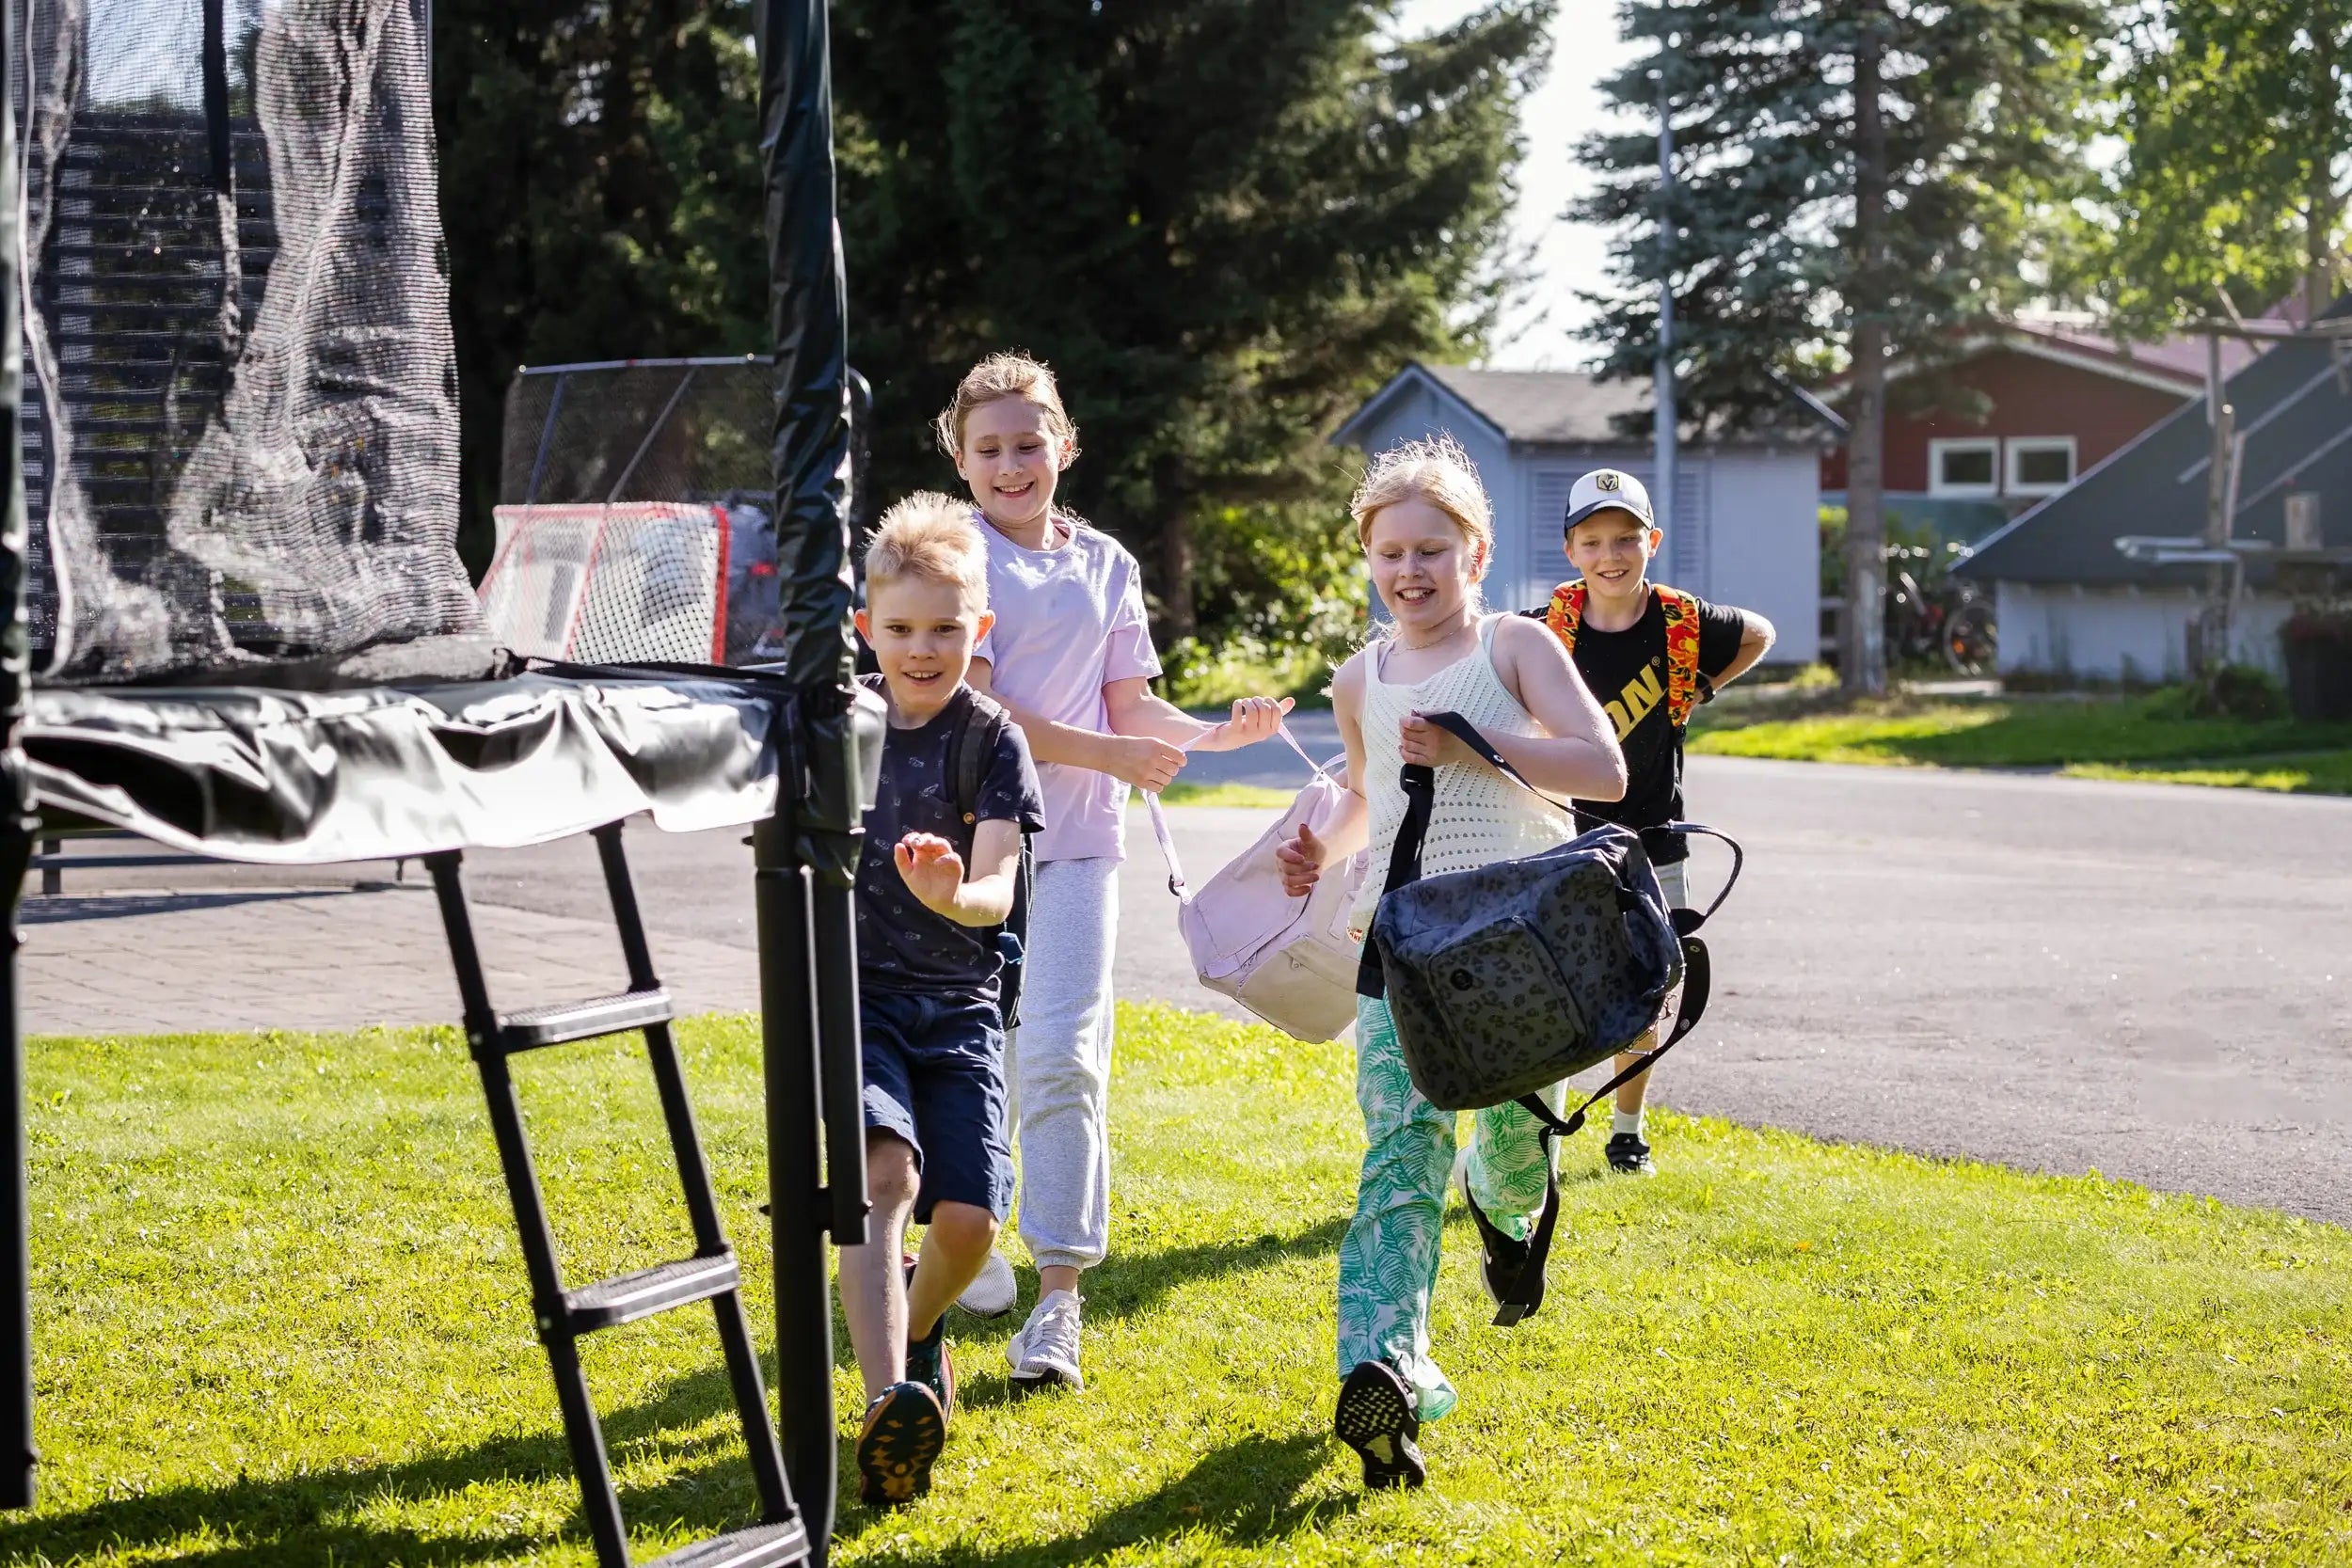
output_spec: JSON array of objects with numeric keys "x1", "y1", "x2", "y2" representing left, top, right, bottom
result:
[{"x1": 842, "y1": 494, "x2": 1044, "y2": 1507}]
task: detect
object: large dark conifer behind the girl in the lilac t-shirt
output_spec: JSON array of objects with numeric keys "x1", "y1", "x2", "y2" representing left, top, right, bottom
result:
[{"x1": 833, "y1": 0, "x2": 1550, "y2": 637}]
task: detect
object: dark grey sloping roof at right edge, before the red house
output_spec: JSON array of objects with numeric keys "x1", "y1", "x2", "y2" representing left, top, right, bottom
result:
[{"x1": 1960, "y1": 301, "x2": 2352, "y2": 583}]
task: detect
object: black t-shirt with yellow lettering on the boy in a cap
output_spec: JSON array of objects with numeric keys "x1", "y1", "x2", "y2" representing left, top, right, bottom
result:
[{"x1": 1529, "y1": 593, "x2": 1748, "y2": 865}]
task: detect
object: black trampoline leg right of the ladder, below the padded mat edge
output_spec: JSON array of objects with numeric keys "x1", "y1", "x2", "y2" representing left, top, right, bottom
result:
[{"x1": 751, "y1": 816, "x2": 837, "y2": 1563}]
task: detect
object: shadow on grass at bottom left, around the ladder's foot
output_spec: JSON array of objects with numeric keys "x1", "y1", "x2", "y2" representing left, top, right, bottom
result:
[{"x1": 0, "y1": 1369, "x2": 781, "y2": 1568}]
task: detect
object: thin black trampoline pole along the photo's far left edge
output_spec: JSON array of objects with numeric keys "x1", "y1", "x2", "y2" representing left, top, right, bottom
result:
[{"x1": 0, "y1": 5, "x2": 36, "y2": 1510}]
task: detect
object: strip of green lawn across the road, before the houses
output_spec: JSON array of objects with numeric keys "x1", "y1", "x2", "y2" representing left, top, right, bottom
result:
[{"x1": 1692, "y1": 691, "x2": 2352, "y2": 792}]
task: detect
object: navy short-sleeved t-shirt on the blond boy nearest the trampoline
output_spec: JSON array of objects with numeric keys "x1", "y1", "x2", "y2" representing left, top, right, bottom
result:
[{"x1": 856, "y1": 687, "x2": 1044, "y2": 1002}]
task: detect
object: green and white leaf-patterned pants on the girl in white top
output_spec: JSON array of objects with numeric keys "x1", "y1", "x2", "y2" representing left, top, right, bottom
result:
[{"x1": 1339, "y1": 997, "x2": 1562, "y2": 1420}]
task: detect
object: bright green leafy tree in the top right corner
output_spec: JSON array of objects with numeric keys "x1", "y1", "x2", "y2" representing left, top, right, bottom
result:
[{"x1": 2073, "y1": 0, "x2": 2352, "y2": 336}]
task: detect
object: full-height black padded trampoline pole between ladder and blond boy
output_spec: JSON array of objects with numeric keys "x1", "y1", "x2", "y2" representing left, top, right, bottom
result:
[{"x1": 753, "y1": 0, "x2": 866, "y2": 1563}]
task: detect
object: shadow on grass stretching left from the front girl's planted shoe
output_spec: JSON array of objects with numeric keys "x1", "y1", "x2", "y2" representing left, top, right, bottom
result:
[{"x1": 835, "y1": 1432, "x2": 1359, "y2": 1568}]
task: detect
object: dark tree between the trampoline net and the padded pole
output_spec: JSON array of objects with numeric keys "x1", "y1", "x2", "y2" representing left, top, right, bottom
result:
[{"x1": 433, "y1": 0, "x2": 767, "y2": 569}]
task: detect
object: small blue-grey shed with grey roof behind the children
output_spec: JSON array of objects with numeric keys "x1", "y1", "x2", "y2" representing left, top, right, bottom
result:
[{"x1": 1331, "y1": 359, "x2": 1820, "y2": 663}]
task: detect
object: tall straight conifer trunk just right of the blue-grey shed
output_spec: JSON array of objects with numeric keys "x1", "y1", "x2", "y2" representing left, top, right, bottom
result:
[{"x1": 1839, "y1": 0, "x2": 1889, "y2": 696}]
